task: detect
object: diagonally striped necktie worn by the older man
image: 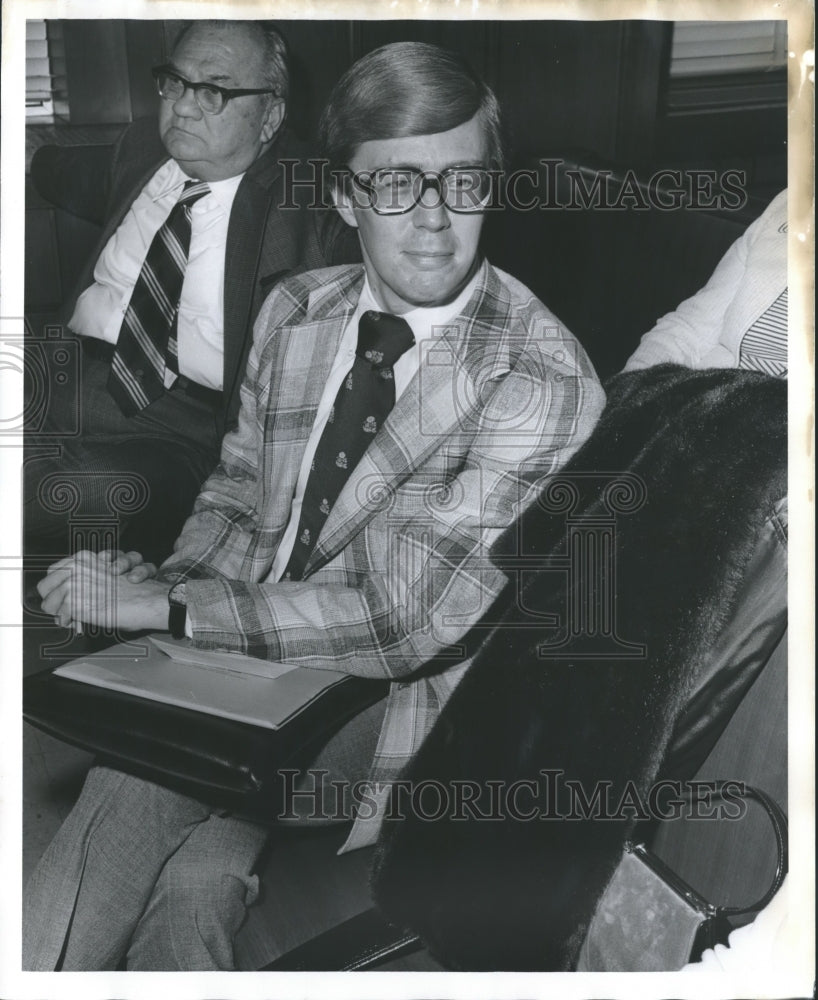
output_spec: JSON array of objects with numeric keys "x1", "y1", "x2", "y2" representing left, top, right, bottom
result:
[{"x1": 108, "y1": 181, "x2": 210, "y2": 417}]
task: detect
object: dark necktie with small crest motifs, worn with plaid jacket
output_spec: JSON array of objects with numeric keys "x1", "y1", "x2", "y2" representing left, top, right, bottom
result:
[{"x1": 283, "y1": 310, "x2": 415, "y2": 580}]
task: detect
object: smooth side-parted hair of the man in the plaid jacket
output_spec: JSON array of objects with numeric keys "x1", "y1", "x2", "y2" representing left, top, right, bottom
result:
[{"x1": 318, "y1": 42, "x2": 505, "y2": 171}]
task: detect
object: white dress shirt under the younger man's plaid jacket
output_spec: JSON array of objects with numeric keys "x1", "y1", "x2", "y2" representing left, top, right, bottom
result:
[{"x1": 267, "y1": 272, "x2": 479, "y2": 582}]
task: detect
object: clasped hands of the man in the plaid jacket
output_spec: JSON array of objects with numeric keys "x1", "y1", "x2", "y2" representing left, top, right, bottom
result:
[{"x1": 37, "y1": 551, "x2": 168, "y2": 631}]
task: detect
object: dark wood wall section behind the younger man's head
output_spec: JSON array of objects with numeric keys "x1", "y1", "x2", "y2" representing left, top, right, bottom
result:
[{"x1": 282, "y1": 21, "x2": 669, "y2": 162}]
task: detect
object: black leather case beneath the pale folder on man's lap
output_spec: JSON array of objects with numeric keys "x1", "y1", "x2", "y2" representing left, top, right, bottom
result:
[{"x1": 23, "y1": 651, "x2": 389, "y2": 821}]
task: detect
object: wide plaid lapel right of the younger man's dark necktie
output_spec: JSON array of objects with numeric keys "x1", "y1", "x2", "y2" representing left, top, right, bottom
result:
[{"x1": 305, "y1": 263, "x2": 509, "y2": 574}]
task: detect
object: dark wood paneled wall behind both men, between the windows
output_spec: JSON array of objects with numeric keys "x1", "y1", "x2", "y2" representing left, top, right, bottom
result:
[{"x1": 54, "y1": 20, "x2": 667, "y2": 159}]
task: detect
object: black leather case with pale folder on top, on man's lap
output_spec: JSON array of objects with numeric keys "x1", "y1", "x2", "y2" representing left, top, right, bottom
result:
[{"x1": 23, "y1": 635, "x2": 389, "y2": 820}]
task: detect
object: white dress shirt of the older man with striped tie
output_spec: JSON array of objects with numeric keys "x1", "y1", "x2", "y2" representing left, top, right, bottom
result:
[{"x1": 68, "y1": 160, "x2": 244, "y2": 389}]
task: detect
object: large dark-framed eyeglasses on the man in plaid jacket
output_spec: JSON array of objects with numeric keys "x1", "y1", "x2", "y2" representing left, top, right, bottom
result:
[{"x1": 350, "y1": 167, "x2": 492, "y2": 215}]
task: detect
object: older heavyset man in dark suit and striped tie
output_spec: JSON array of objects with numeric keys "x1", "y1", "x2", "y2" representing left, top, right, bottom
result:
[{"x1": 25, "y1": 21, "x2": 342, "y2": 559}]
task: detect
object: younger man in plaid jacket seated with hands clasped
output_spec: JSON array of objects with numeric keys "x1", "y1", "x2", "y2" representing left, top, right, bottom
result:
[{"x1": 30, "y1": 42, "x2": 604, "y2": 969}]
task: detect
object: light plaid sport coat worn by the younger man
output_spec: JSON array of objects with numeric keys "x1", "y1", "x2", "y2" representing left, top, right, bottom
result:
[{"x1": 161, "y1": 262, "x2": 604, "y2": 849}]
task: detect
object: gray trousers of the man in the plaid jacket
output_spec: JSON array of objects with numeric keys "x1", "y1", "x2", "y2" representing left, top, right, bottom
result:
[{"x1": 23, "y1": 701, "x2": 385, "y2": 971}]
